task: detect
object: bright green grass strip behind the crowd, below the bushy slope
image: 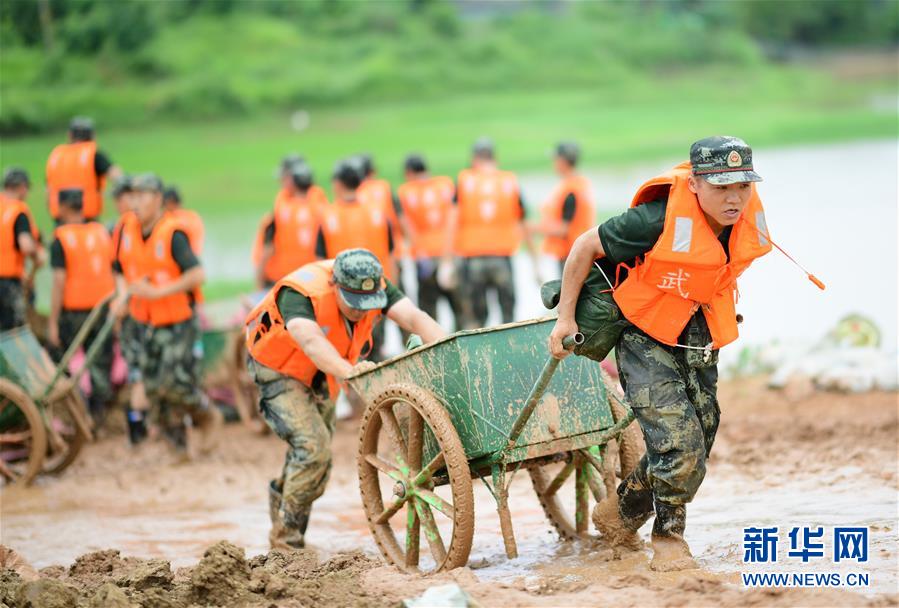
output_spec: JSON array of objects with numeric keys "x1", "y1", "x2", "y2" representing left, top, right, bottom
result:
[{"x1": 0, "y1": 69, "x2": 897, "y2": 299}]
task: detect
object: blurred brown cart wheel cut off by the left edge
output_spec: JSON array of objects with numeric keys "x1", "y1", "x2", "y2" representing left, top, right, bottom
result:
[{"x1": 0, "y1": 378, "x2": 47, "y2": 485}]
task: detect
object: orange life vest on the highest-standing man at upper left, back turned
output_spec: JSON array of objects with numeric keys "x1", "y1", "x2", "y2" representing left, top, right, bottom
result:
[{"x1": 47, "y1": 141, "x2": 106, "y2": 220}]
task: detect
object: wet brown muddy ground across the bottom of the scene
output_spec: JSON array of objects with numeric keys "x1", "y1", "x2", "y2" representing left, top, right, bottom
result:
[{"x1": 0, "y1": 380, "x2": 899, "y2": 607}]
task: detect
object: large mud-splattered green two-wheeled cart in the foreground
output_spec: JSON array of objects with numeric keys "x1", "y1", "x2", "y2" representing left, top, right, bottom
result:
[{"x1": 349, "y1": 317, "x2": 643, "y2": 572}]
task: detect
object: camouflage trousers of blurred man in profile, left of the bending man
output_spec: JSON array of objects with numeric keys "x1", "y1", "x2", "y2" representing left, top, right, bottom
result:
[{"x1": 140, "y1": 316, "x2": 210, "y2": 448}]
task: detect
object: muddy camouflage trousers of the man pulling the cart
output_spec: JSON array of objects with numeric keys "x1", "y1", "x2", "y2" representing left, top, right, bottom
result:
[{"x1": 616, "y1": 314, "x2": 721, "y2": 508}]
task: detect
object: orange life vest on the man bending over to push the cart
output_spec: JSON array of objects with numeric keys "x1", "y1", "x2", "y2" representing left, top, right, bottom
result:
[{"x1": 246, "y1": 260, "x2": 381, "y2": 399}]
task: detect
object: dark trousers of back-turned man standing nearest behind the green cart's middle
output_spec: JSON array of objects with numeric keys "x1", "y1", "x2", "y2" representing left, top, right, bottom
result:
[{"x1": 459, "y1": 255, "x2": 515, "y2": 329}]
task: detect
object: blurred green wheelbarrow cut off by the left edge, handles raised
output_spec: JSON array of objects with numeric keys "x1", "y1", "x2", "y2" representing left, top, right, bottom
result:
[{"x1": 0, "y1": 296, "x2": 119, "y2": 485}]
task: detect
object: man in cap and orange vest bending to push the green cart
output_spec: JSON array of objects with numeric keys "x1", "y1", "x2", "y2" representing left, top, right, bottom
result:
[{"x1": 247, "y1": 249, "x2": 445, "y2": 549}]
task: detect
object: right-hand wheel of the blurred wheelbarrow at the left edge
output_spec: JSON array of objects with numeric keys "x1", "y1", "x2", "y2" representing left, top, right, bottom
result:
[{"x1": 43, "y1": 386, "x2": 90, "y2": 474}]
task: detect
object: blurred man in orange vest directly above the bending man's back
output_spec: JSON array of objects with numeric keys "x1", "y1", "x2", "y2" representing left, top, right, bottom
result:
[{"x1": 256, "y1": 162, "x2": 322, "y2": 287}]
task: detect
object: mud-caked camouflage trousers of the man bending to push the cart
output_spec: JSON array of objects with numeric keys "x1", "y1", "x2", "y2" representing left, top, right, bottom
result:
[{"x1": 247, "y1": 358, "x2": 336, "y2": 528}]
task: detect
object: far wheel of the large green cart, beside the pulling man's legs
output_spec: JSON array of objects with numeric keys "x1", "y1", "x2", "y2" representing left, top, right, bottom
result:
[{"x1": 528, "y1": 392, "x2": 643, "y2": 540}]
